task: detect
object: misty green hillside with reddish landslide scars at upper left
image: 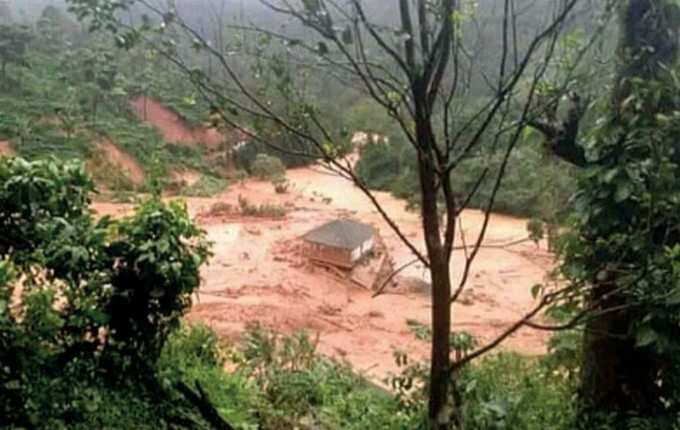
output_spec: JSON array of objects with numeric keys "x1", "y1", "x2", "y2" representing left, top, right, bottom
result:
[{"x1": 0, "y1": 2, "x2": 244, "y2": 196}]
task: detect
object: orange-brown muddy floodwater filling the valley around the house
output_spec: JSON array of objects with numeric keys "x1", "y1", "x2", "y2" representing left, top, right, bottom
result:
[{"x1": 97, "y1": 162, "x2": 552, "y2": 381}]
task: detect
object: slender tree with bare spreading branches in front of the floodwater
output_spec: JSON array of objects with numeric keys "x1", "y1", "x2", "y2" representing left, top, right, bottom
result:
[{"x1": 70, "y1": 0, "x2": 612, "y2": 429}]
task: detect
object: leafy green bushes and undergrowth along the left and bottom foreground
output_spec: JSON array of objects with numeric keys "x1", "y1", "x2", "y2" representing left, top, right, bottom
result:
[{"x1": 0, "y1": 159, "x2": 584, "y2": 430}]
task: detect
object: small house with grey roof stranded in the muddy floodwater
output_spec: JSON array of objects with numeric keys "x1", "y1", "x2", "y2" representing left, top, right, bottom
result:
[{"x1": 303, "y1": 219, "x2": 375, "y2": 269}]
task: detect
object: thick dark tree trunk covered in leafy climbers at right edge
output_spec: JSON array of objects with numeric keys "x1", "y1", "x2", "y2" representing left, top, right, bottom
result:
[{"x1": 532, "y1": 0, "x2": 680, "y2": 428}]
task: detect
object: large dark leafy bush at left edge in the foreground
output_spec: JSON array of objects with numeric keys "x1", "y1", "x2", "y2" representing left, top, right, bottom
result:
[{"x1": 0, "y1": 158, "x2": 208, "y2": 428}]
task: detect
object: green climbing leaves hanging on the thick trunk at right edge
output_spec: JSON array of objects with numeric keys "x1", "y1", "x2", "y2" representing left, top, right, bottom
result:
[{"x1": 553, "y1": 72, "x2": 680, "y2": 422}]
